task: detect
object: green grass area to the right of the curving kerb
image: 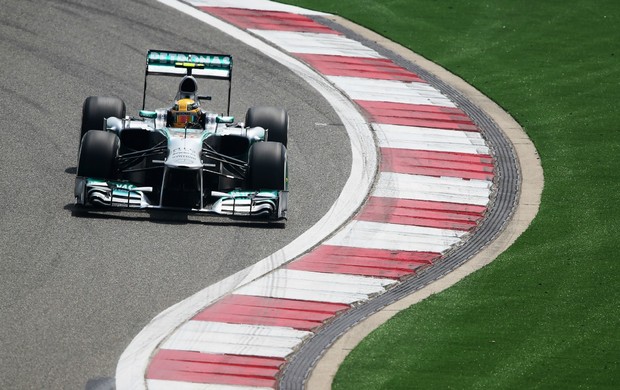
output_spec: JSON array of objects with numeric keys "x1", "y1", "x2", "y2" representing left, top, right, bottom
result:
[{"x1": 286, "y1": 0, "x2": 620, "y2": 390}]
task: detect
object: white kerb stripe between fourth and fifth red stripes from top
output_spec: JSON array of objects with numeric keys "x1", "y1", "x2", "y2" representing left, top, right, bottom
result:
[{"x1": 372, "y1": 172, "x2": 492, "y2": 206}]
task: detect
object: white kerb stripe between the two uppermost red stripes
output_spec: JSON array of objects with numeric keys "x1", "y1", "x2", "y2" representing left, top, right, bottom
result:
[{"x1": 248, "y1": 29, "x2": 384, "y2": 58}]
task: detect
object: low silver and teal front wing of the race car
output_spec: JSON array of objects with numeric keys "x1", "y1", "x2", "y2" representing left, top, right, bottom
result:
[{"x1": 74, "y1": 176, "x2": 288, "y2": 220}]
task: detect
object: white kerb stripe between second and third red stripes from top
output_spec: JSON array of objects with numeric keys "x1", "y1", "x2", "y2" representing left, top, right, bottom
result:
[{"x1": 326, "y1": 76, "x2": 456, "y2": 107}]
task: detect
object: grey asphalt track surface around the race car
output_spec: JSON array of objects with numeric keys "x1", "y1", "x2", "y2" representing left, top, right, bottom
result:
[{"x1": 0, "y1": 0, "x2": 351, "y2": 389}]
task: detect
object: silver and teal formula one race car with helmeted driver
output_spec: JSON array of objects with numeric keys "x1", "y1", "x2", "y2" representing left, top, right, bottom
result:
[{"x1": 75, "y1": 50, "x2": 289, "y2": 220}]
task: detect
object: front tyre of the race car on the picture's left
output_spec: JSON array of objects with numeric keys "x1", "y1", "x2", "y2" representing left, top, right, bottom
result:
[{"x1": 77, "y1": 130, "x2": 120, "y2": 179}]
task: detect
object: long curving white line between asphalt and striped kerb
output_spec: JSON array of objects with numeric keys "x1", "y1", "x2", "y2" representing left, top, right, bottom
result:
[{"x1": 116, "y1": 0, "x2": 377, "y2": 390}]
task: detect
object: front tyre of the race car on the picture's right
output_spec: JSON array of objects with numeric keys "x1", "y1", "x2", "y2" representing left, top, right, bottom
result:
[{"x1": 246, "y1": 141, "x2": 288, "y2": 190}]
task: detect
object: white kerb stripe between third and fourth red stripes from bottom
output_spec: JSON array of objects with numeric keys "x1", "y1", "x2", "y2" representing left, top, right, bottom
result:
[{"x1": 325, "y1": 221, "x2": 465, "y2": 252}]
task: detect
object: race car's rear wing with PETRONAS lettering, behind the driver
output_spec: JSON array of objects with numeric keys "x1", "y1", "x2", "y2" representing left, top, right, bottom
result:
[{"x1": 142, "y1": 50, "x2": 233, "y2": 115}]
